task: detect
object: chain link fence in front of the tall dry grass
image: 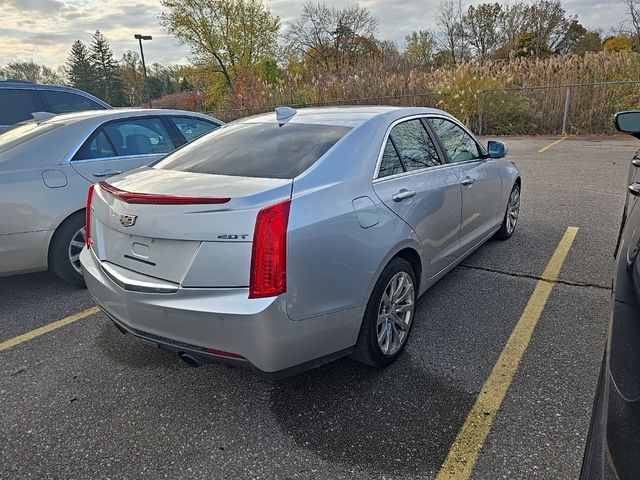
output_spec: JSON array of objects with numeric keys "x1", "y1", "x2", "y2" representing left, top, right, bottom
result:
[{"x1": 208, "y1": 80, "x2": 640, "y2": 135}]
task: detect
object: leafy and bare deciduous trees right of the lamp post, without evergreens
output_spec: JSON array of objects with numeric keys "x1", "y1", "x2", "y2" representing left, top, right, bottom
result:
[{"x1": 160, "y1": 0, "x2": 640, "y2": 104}]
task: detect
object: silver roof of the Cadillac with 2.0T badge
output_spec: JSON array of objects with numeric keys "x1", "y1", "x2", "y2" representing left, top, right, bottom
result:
[{"x1": 239, "y1": 105, "x2": 450, "y2": 128}]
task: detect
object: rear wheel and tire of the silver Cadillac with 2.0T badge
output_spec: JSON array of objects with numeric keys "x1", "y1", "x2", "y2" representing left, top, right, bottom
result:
[{"x1": 351, "y1": 257, "x2": 417, "y2": 367}]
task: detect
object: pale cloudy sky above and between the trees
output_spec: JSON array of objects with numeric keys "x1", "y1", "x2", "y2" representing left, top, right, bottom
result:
[{"x1": 0, "y1": 0, "x2": 626, "y2": 67}]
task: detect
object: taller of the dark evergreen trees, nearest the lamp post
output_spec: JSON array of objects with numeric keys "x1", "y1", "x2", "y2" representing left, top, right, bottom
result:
[{"x1": 91, "y1": 30, "x2": 126, "y2": 106}]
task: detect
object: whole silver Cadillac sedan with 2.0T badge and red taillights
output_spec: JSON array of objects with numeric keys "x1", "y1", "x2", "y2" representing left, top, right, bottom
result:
[{"x1": 80, "y1": 107, "x2": 521, "y2": 377}]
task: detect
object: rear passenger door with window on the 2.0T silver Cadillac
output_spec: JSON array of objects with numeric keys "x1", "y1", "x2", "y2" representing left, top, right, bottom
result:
[{"x1": 373, "y1": 118, "x2": 461, "y2": 277}]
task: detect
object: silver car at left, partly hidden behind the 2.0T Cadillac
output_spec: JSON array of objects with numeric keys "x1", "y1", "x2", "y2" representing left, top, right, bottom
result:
[{"x1": 0, "y1": 109, "x2": 222, "y2": 286}]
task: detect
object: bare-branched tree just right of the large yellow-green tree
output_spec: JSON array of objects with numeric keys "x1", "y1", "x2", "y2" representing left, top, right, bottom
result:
[{"x1": 285, "y1": 2, "x2": 379, "y2": 72}]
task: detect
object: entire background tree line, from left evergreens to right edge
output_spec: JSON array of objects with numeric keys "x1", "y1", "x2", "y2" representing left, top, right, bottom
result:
[{"x1": 0, "y1": 0, "x2": 640, "y2": 108}]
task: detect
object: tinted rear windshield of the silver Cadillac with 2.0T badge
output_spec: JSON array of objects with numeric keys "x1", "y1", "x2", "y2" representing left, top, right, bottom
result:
[{"x1": 154, "y1": 123, "x2": 351, "y2": 178}]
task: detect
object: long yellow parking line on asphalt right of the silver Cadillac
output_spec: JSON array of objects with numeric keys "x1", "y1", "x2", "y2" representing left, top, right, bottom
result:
[{"x1": 436, "y1": 227, "x2": 578, "y2": 480}]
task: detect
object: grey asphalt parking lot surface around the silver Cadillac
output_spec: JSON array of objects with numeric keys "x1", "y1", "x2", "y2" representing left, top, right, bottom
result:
[{"x1": 0, "y1": 137, "x2": 639, "y2": 480}]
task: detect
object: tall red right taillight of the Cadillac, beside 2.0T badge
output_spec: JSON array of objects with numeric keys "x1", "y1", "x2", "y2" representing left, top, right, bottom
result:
[{"x1": 249, "y1": 200, "x2": 291, "y2": 298}]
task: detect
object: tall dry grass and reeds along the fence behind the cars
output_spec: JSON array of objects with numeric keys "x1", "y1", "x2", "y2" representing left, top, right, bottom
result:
[{"x1": 172, "y1": 52, "x2": 640, "y2": 134}]
